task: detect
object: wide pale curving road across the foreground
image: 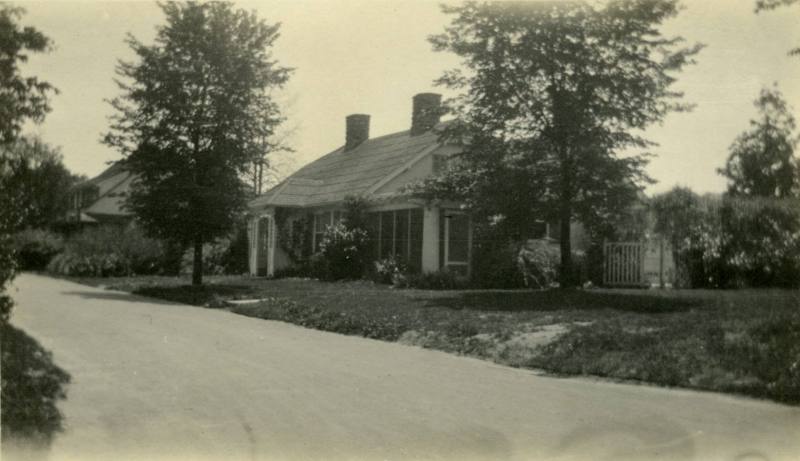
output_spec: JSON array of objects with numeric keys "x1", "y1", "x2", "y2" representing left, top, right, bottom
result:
[{"x1": 4, "y1": 274, "x2": 800, "y2": 461}]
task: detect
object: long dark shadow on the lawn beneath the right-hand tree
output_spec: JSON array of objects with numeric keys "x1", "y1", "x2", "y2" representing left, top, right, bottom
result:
[{"x1": 422, "y1": 290, "x2": 702, "y2": 314}]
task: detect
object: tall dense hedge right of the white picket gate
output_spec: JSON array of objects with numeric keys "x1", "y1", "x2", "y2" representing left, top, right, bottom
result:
[{"x1": 654, "y1": 189, "x2": 800, "y2": 288}]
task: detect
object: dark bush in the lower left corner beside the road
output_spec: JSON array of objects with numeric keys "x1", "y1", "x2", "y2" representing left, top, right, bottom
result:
[{"x1": 0, "y1": 324, "x2": 70, "y2": 451}]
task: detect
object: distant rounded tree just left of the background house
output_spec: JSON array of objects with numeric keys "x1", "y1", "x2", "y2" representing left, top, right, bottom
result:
[{"x1": 0, "y1": 137, "x2": 81, "y2": 228}]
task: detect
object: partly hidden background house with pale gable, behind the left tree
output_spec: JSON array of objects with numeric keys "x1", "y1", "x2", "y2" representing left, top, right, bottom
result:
[{"x1": 65, "y1": 161, "x2": 134, "y2": 225}]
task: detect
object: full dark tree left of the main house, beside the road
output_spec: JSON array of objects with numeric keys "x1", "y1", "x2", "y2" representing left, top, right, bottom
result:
[{"x1": 105, "y1": 2, "x2": 291, "y2": 285}]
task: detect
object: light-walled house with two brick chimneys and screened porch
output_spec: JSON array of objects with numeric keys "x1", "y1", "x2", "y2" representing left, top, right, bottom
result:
[{"x1": 248, "y1": 93, "x2": 584, "y2": 276}]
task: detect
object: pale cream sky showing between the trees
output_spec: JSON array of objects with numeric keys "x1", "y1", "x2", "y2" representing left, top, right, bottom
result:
[{"x1": 19, "y1": 0, "x2": 800, "y2": 193}]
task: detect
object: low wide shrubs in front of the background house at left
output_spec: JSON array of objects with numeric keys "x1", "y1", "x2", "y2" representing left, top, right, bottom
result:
[{"x1": 47, "y1": 224, "x2": 164, "y2": 277}]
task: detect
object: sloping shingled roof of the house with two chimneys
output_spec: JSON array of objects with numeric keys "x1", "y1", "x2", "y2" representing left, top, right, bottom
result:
[{"x1": 250, "y1": 124, "x2": 439, "y2": 208}]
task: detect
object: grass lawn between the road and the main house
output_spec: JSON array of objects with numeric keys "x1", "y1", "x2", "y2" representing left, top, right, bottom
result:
[{"x1": 73, "y1": 276, "x2": 800, "y2": 404}]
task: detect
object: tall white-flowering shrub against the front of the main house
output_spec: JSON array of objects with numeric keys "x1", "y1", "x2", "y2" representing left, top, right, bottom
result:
[{"x1": 316, "y1": 223, "x2": 367, "y2": 280}]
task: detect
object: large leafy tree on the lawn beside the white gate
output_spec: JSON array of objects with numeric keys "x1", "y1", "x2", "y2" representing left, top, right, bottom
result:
[{"x1": 430, "y1": 0, "x2": 701, "y2": 286}]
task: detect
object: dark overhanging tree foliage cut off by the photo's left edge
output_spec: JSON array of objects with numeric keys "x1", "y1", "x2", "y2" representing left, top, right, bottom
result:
[{"x1": 0, "y1": 4, "x2": 56, "y2": 325}]
